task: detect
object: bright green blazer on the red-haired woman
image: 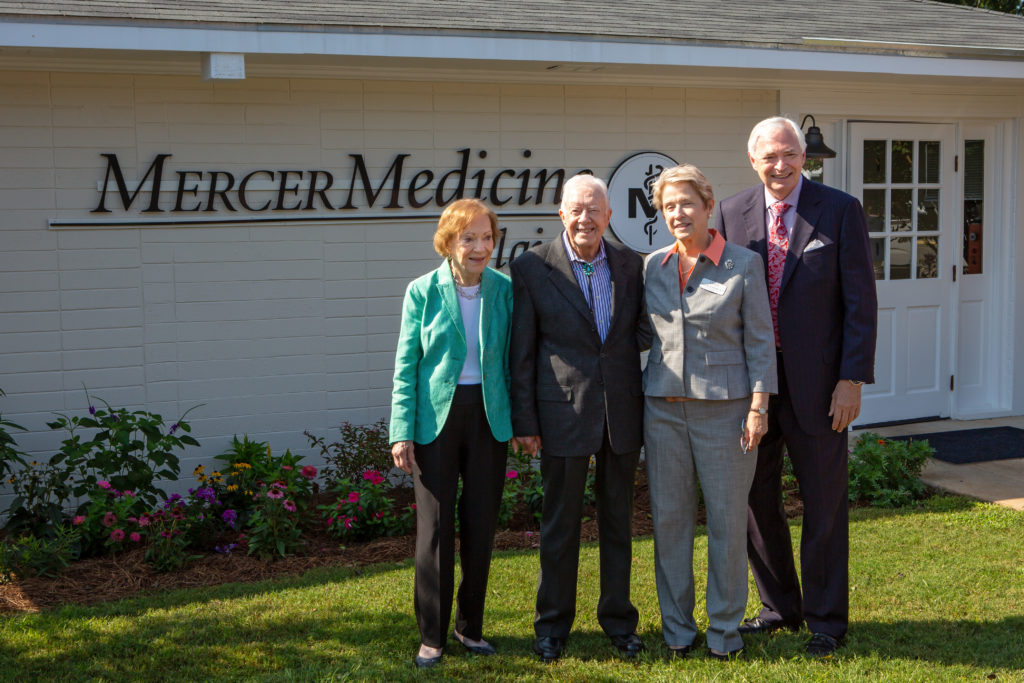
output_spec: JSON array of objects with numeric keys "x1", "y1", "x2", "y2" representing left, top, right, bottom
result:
[{"x1": 390, "y1": 261, "x2": 512, "y2": 443}]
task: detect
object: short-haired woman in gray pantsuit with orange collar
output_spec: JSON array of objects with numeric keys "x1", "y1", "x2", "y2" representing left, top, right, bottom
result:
[{"x1": 643, "y1": 164, "x2": 777, "y2": 659}]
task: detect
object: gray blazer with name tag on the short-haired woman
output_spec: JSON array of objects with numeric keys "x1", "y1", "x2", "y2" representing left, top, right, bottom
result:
[{"x1": 643, "y1": 244, "x2": 778, "y2": 400}]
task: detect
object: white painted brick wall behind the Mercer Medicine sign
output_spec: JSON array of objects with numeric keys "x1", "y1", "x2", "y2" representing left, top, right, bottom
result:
[{"x1": 0, "y1": 73, "x2": 778, "y2": 497}]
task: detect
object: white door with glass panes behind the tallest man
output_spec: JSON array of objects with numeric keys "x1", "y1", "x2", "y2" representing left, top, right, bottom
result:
[{"x1": 848, "y1": 123, "x2": 961, "y2": 424}]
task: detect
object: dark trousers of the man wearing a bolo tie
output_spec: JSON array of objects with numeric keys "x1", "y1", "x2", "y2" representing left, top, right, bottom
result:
[{"x1": 534, "y1": 427, "x2": 640, "y2": 639}]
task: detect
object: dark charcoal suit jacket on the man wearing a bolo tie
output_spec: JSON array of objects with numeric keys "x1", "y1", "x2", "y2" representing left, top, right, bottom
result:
[{"x1": 509, "y1": 237, "x2": 650, "y2": 456}]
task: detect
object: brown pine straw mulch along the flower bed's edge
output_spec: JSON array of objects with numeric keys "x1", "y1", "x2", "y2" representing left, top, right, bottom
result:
[{"x1": 0, "y1": 469, "x2": 803, "y2": 612}]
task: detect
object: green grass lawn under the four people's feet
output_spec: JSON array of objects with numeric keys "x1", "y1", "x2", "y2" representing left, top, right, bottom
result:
[{"x1": 0, "y1": 498, "x2": 1024, "y2": 683}]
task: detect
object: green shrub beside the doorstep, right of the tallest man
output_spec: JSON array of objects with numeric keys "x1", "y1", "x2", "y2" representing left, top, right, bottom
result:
[{"x1": 850, "y1": 432, "x2": 935, "y2": 508}]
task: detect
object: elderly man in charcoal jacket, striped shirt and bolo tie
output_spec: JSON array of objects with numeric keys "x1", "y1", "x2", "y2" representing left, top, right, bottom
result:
[{"x1": 509, "y1": 175, "x2": 650, "y2": 663}]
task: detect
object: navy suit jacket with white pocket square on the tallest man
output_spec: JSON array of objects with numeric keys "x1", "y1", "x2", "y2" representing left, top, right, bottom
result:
[{"x1": 716, "y1": 178, "x2": 879, "y2": 434}]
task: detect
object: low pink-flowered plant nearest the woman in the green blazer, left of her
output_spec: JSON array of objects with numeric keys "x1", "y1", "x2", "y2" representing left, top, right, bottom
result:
[{"x1": 319, "y1": 470, "x2": 416, "y2": 541}]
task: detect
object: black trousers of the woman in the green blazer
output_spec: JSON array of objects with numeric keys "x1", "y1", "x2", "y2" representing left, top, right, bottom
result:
[{"x1": 413, "y1": 384, "x2": 508, "y2": 647}]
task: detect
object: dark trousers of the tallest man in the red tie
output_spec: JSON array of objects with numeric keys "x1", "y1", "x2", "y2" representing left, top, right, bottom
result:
[{"x1": 746, "y1": 354, "x2": 850, "y2": 638}]
